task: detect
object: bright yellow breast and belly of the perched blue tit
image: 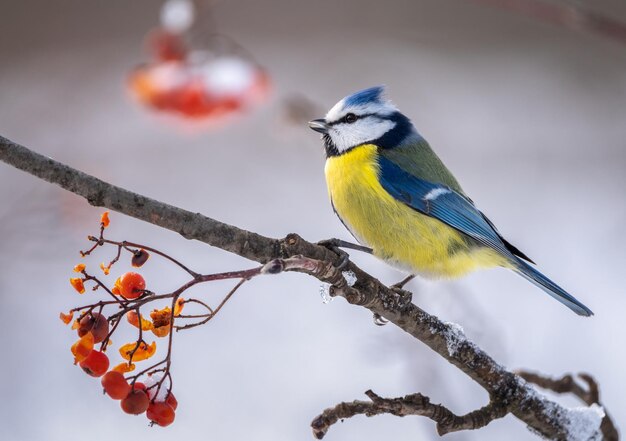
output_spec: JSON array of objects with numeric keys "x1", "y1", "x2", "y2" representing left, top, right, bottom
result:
[{"x1": 325, "y1": 144, "x2": 504, "y2": 277}]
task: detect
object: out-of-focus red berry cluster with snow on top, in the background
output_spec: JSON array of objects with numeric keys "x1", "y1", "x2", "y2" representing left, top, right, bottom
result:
[{"x1": 128, "y1": 18, "x2": 270, "y2": 121}]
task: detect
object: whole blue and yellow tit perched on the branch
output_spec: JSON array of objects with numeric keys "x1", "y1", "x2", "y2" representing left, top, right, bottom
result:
[{"x1": 309, "y1": 87, "x2": 593, "y2": 316}]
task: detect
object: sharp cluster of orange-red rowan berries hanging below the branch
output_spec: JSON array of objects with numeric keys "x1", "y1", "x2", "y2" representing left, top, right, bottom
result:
[{"x1": 60, "y1": 212, "x2": 263, "y2": 427}]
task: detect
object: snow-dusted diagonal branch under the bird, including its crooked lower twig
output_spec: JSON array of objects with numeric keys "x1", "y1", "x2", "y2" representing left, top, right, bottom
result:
[{"x1": 0, "y1": 136, "x2": 617, "y2": 440}]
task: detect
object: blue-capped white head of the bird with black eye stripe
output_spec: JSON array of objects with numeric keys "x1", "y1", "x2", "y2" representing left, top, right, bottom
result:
[{"x1": 309, "y1": 86, "x2": 419, "y2": 156}]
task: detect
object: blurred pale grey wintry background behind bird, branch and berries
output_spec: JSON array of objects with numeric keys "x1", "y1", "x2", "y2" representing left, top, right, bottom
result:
[{"x1": 0, "y1": 0, "x2": 626, "y2": 441}]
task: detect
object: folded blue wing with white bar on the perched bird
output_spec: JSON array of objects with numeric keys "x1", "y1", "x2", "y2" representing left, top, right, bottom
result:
[{"x1": 379, "y1": 156, "x2": 515, "y2": 260}]
